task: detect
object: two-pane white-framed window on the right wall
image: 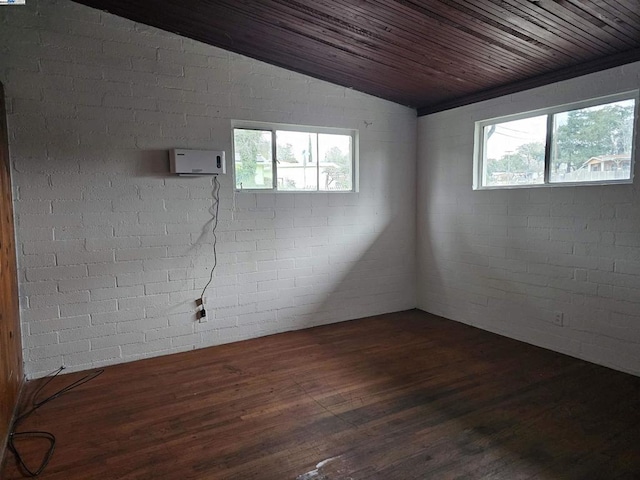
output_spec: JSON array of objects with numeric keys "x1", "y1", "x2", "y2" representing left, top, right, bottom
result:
[{"x1": 474, "y1": 92, "x2": 638, "y2": 188}]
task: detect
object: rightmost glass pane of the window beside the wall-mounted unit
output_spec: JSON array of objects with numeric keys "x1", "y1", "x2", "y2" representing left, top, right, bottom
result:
[{"x1": 318, "y1": 134, "x2": 353, "y2": 191}]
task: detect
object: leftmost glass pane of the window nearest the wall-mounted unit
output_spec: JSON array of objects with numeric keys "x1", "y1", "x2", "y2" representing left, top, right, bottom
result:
[{"x1": 233, "y1": 128, "x2": 273, "y2": 189}]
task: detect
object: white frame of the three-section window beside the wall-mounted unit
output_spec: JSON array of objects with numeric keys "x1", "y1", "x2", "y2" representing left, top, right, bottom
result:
[{"x1": 231, "y1": 120, "x2": 360, "y2": 194}]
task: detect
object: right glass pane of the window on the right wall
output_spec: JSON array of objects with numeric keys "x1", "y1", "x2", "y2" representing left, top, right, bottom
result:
[{"x1": 549, "y1": 99, "x2": 635, "y2": 182}]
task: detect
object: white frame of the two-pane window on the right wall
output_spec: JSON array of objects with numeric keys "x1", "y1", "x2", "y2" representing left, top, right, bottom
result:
[{"x1": 473, "y1": 89, "x2": 640, "y2": 190}]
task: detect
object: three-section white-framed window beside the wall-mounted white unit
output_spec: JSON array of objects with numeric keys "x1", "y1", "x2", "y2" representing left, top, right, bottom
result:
[{"x1": 233, "y1": 122, "x2": 357, "y2": 192}]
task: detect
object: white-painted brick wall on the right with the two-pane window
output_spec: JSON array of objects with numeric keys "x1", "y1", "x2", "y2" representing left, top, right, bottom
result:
[{"x1": 417, "y1": 63, "x2": 640, "y2": 374}]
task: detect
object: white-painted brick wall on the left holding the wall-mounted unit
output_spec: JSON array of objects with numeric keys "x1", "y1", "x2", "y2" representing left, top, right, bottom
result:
[{"x1": 0, "y1": 0, "x2": 417, "y2": 377}]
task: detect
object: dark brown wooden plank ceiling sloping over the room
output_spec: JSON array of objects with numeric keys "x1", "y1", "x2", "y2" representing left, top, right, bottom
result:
[{"x1": 71, "y1": 0, "x2": 640, "y2": 114}]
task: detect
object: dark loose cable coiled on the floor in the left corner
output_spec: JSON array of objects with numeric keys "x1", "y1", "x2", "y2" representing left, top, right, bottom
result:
[{"x1": 7, "y1": 367, "x2": 104, "y2": 477}]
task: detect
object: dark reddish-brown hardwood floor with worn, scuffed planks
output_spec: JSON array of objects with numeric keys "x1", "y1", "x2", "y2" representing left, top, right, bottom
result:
[{"x1": 2, "y1": 311, "x2": 640, "y2": 480}]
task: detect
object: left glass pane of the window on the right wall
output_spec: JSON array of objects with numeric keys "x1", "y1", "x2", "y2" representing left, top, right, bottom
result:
[{"x1": 482, "y1": 115, "x2": 547, "y2": 186}]
